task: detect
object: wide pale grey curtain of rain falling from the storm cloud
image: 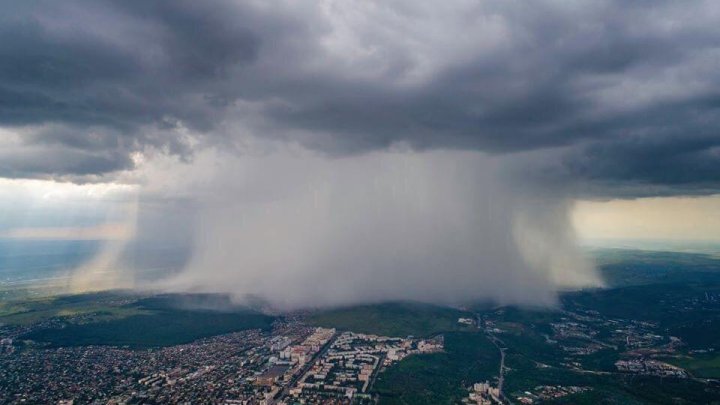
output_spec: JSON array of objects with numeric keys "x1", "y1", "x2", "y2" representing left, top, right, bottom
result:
[{"x1": 153, "y1": 147, "x2": 602, "y2": 309}]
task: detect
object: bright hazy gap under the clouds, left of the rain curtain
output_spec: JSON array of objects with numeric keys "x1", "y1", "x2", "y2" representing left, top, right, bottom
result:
[{"x1": 0, "y1": 179, "x2": 138, "y2": 291}]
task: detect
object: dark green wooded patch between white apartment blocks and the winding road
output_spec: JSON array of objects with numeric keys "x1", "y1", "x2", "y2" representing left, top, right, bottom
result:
[{"x1": 375, "y1": 332, "x2": 500, "y2": 405}]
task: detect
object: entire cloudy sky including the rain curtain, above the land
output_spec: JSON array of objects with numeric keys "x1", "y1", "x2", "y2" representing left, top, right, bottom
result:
[{"x1": 0, "y1": 0, "x2": 720, "y2": 307}]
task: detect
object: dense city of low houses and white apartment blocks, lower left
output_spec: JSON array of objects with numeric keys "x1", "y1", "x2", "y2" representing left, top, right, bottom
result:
[{"x1": 0, "y1": 304, "x2": 450, "y2": 405}]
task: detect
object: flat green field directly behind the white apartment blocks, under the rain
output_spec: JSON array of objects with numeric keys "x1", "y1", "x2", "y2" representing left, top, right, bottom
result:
[{"x1": 307, "y1": 302, "x2": 473, "y2": 337}]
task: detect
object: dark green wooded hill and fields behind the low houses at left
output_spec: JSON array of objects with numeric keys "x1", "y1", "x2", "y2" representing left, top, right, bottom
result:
[{"x1": 0, "y1": 292, "x2": 275, "y2": 348}]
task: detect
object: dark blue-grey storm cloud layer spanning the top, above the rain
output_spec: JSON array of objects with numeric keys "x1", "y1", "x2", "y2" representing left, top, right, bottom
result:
[{"x1": 0, "y1": 1, "x2": 720, "y2": 194}]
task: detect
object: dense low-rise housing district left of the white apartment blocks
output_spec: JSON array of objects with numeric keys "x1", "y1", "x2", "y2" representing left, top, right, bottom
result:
[{"x1": 0, "y1": 324, "x2": 314, "y2": 405}]
